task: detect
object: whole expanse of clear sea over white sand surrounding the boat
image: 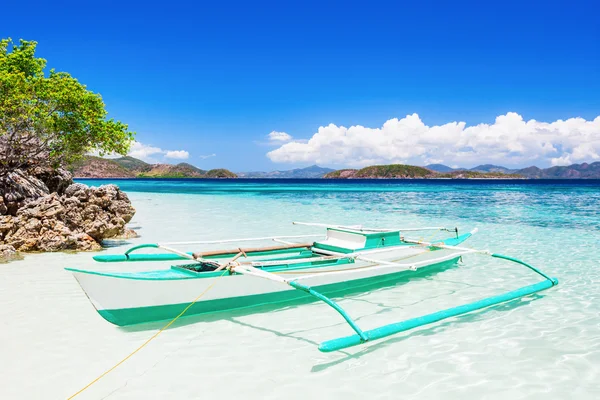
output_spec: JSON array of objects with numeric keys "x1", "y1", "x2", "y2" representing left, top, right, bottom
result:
[{"x1": 0, "y1": 180, "x2": 600, "y2": 400}]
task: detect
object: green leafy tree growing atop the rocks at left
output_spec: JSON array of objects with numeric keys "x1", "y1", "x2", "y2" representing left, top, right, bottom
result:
[{"x1": 0, "y1": 38, "x2": 134, "y2": 179}]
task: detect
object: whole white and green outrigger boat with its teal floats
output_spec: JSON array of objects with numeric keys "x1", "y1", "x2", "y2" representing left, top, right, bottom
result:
[{"x1": 66, "y1": 222, "x2": 558, "y2": 352}]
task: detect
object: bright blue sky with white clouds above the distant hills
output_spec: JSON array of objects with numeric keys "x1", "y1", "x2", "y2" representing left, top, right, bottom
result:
[{"x1": 0, "y1": 0, "x2": 600, "y2": 171}]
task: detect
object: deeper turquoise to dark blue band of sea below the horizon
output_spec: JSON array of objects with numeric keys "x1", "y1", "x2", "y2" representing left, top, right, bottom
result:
[{"x1": 81, "y1": 179, "x2": 600, "y2": 229}]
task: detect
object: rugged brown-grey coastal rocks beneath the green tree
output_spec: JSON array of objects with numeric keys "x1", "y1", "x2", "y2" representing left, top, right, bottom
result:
[{"x1": 0, "y1": 170, "x2": 135, "y2": 257}]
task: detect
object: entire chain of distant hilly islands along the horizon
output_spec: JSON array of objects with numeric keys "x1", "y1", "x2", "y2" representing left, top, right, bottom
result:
[{"x1": 70, "y1": 156, "x2": 600, "y2": 179}]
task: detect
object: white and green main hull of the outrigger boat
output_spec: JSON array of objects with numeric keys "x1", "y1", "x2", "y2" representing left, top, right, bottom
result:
[{"x1": 72, "y1": 247, "x2": 459, "y2": 326}]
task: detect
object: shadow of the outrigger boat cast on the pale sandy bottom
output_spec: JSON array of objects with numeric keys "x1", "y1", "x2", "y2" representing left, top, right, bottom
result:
[{"x1": 118, "y1": 264, "x2": 544, "y2": 372}]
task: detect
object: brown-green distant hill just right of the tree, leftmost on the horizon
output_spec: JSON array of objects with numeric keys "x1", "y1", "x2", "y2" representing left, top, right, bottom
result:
[{"x1": 70, "y1": 156, "x2": 237, "y2": 178}]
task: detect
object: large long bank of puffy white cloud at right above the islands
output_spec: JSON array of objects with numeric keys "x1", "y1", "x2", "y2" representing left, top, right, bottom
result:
[{"x1": 267, "y1": 112, "x2": 600, "y2": 166}]
